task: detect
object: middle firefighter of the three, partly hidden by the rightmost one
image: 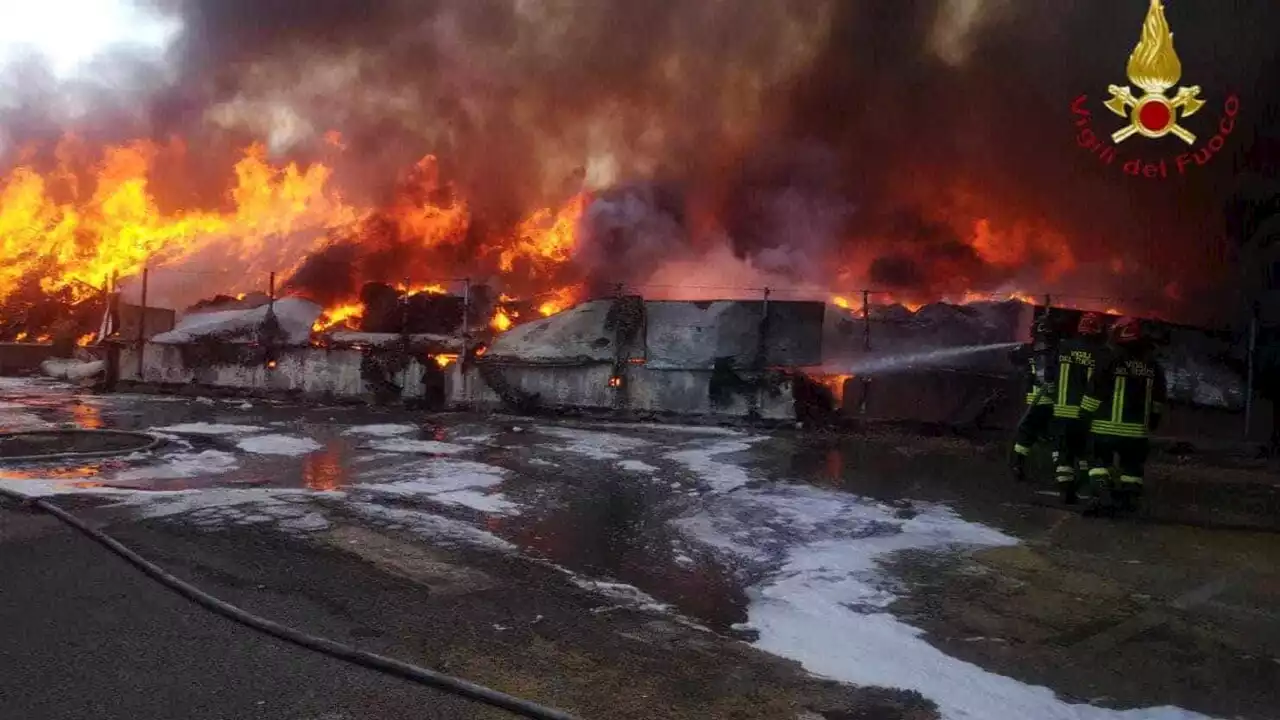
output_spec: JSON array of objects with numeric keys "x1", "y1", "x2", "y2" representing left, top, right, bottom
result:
[{"x1": 1050, "y1": 313, "x2": 1106, "y2": 505}]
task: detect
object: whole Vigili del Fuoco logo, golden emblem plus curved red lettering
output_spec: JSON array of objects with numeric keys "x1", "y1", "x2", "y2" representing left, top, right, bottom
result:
[{"x1": 1071, "y1": 0, "x2": 1240, "y2": 179}]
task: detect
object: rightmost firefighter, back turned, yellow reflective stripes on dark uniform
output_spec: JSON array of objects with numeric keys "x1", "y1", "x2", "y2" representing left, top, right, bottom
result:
[{"x1": 1080, "y1": 318, "x2": 1166, "y2": 512}]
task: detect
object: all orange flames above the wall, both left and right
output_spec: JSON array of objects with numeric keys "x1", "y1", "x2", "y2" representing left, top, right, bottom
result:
[{"x1": 0, "y1": 133, "x2": 1141, "y2": 345}]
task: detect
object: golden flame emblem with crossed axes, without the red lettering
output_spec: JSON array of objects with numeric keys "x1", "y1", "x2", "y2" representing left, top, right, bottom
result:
[{"x1": 1105, "y1": 0, "x2": 1204, "y2": 145}]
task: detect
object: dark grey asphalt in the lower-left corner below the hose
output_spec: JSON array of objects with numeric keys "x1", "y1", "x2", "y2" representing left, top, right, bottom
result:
[{"x1": 0, "y1": 506, "x2": 476, "y2": 720}]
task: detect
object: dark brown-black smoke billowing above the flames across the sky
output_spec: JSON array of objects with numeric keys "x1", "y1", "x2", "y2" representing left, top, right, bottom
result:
[{"x1": 2, "y1": 0, "x2": 1280, "y2": 319}]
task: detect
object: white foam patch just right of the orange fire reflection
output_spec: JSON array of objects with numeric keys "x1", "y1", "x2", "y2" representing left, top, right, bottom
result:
[{"x1": 360, "y1": 460, "x2": 520, "y2": 514}]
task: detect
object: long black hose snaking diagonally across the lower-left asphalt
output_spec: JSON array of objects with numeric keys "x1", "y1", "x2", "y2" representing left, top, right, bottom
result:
[{"x1": 0, "y1": 488, "x2": 579, "y2": 720}]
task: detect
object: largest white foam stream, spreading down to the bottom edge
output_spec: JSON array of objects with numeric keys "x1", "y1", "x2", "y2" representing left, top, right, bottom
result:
[{"x1": 673, "y1": 442, "x2": 1206, "y2": 720}]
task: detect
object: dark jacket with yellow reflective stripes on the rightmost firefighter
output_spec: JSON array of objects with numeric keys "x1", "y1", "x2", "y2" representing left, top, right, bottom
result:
[{"x1": 1080, "y1": 348, "x2": 1167, "y2": 438}]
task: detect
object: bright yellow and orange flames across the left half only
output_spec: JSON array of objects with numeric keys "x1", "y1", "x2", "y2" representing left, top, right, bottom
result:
[{"x1": 0, "y1": 133, "x2": 586, "y2": 345}]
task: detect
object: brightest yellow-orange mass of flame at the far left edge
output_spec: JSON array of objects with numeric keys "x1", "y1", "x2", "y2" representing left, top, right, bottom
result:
[{"x1": 0, "y1": 142, "x2": 360, "y2": 302}]
